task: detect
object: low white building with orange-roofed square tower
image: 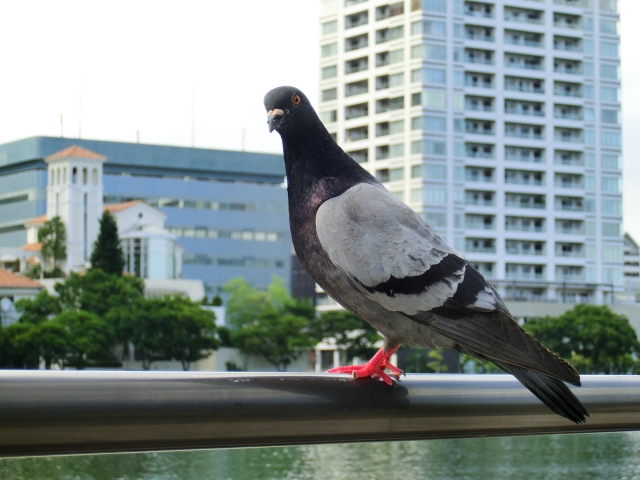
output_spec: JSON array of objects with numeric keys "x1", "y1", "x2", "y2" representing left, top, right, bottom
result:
[{"x1": 0, "y1": 145, "x2": 204, "y2": 300}]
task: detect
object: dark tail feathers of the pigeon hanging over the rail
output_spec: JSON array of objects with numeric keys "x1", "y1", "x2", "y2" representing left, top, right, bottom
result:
[{"x1": 496, "y1": 362, "x2": 589, "y2": 423}]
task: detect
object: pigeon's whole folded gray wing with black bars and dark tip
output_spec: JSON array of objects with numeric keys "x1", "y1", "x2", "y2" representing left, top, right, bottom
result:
[{"x1": 316, "y1": 184, "x2": 579, "y2": 384}]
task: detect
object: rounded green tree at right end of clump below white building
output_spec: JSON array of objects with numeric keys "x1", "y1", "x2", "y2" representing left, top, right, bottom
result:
[{"x1": 127, "y1": 296, "x2": 220, "y2": 370}]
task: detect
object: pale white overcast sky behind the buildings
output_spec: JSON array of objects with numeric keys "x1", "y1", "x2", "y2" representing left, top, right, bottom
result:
[{"x1": 0, "y1": 0, "x2": 640, "y2": 240}]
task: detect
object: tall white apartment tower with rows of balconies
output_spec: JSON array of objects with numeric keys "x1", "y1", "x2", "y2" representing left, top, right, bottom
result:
[{"x1": 319, "y1": 0, "x2": 623, "y2": 303}]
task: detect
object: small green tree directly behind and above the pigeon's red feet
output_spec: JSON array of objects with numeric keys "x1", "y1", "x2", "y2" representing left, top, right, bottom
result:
[{"x1": 314, "y1": 310, "x2": 382, "y2": 361}]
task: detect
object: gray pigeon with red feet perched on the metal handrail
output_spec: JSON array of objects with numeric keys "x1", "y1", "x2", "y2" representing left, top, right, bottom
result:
[{"x1": 264, "y1": 86, "x2": 589, "y2": 423}]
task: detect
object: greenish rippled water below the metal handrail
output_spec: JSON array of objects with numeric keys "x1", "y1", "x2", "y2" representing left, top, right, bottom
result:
[{"x1": 0, "y1": 432, "x2": 640, "y2": 480}]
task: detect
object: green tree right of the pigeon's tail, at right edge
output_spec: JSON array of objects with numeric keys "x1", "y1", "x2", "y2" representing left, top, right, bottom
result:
[{"x1": 524, "y1": 305, "x2": 640, "y2": 373}]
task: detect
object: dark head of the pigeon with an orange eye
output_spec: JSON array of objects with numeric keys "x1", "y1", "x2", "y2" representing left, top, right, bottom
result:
[{"x1": 264, "y1": 87, "x2": 315, "y2": 134}]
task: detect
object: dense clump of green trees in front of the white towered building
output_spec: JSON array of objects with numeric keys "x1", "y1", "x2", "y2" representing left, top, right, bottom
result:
[{"x1": 0, "y1": 269, "x2": 219, "y2": 370}]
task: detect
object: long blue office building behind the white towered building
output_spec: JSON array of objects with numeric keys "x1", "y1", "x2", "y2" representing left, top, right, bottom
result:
[{"x1": 0, "y1": 133, "x2": 291, "y2": 296}]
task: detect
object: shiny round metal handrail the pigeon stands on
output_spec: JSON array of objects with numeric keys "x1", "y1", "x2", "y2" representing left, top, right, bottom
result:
[{"x1": 0, "y1": 371, "x2": 640, "y2": 456}]
